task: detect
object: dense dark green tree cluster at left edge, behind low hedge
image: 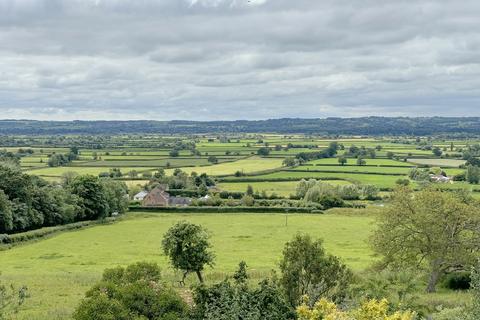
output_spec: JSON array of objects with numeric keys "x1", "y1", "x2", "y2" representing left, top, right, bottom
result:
[{"x1": 0, "y1": 164, "x2": 128, "y2": 233}]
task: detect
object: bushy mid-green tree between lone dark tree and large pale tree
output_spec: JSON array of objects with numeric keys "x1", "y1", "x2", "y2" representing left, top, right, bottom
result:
[{"x1": 279, "y1": 234, "x2": 352, "y2": 306}]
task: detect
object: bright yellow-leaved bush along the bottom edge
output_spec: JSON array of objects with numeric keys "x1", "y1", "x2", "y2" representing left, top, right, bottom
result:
[{"x1": 297, "y1": 298, "x2": 416, "y2": 320}]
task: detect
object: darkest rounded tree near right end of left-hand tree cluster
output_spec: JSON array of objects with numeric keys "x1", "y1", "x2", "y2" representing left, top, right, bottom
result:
[{"x1": 69, "y1": 175, "x2": 109, "y2": 220}]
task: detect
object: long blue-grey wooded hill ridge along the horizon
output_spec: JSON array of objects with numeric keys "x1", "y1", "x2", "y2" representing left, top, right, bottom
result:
[{"x1": 0, "y1": 117, "x2": 480, "y2": 135}]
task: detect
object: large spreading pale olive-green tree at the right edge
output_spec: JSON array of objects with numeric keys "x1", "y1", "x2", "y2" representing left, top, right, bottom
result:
[{"x1": 371, "y1": 187, "x2": 480, "y2": 292}]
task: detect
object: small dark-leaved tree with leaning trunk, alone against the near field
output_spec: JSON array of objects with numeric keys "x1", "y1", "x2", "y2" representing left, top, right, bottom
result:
[{"x1": 162, "y1": 221, "x2": 215, "y2": 283}]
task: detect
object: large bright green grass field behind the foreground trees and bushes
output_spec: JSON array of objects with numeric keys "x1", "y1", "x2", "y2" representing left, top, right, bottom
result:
[{"x1": 0, "y1": 213, "x2": 374, "y2": 320}]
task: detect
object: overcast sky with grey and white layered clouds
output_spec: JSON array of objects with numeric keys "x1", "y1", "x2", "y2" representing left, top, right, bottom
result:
[{"x1": 0, "y1": 0, "x2": 480, "y2": 120}]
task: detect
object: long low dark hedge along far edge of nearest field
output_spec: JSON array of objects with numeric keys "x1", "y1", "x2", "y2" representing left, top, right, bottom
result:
[{"x1": 129, "y1": 206, "x2": 323, "y2": 213}]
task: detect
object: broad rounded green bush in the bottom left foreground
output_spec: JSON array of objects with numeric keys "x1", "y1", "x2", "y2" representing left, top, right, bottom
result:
[{"x1": 73, "y1": 262, "x2": 188, "y2": 320}]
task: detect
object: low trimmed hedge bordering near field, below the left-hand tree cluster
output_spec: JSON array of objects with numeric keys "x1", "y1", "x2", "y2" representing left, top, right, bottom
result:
[{"x1": 0, "y1": 218, "x2": 116, "y2": 250}]
